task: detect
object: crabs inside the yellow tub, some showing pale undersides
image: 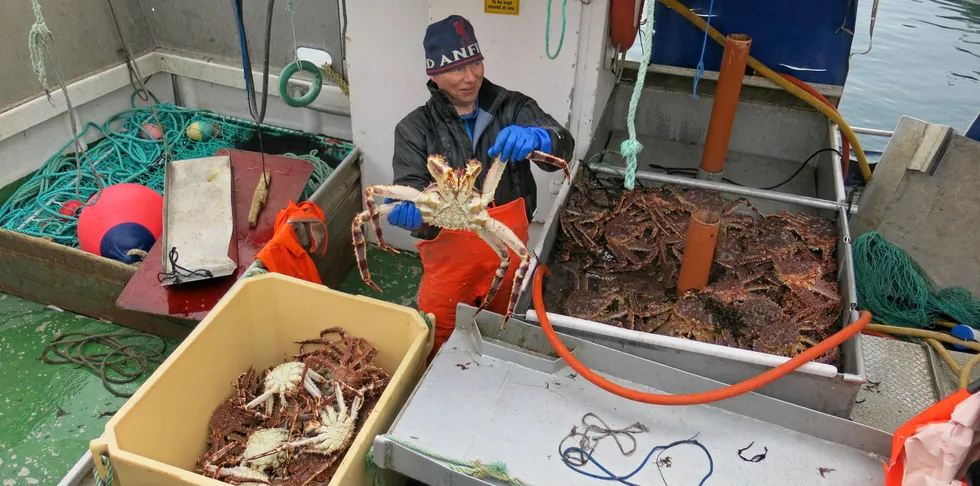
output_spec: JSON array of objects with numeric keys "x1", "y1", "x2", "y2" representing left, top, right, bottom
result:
[{"x1": 197, "y1": 328, "x2": 391, "y2": 486}]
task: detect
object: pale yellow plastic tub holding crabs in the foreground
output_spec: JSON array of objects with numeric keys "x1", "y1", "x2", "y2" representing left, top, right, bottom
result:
[{"x1": 89, "y1": 273, "x2": 432, "y2": 486}]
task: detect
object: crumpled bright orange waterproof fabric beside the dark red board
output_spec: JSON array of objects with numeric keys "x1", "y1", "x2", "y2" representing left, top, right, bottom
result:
[{"x1": 256, "y1": 201, "x2": 327, "y2": 285}]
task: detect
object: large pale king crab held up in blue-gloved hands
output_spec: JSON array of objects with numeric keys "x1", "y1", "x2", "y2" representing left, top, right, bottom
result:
[{"x1": 351, "y1": 151, "x2": 571, "y2": 328}]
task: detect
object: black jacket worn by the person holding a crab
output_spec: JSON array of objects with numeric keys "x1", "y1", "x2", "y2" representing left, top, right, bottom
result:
[{"x1": 391, "y1": 78, "x2": 575, "y2": 239}]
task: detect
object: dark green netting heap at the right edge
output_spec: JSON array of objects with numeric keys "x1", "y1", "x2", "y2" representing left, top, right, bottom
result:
[{"x1": 853, "y1": 232, "x2": 980, "y2": 329}]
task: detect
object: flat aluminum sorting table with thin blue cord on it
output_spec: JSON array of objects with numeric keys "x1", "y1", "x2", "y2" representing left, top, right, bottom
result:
[{"x1": 374, "y1": 305, "x2": 892, "y2": 486}]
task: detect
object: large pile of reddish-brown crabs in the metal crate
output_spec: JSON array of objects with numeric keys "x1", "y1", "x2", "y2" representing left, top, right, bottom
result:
[{"x1": 545, "y1": 178, "x2": 842, "y2": 365}]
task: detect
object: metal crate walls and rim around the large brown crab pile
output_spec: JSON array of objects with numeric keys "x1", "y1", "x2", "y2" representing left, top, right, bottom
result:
[{"x1": 516, "y1": 163, "x2": 867, "y2": 417}]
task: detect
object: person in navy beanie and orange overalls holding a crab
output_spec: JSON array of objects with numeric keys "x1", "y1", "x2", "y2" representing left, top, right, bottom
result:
[{"x1": 386, "y1": 15, "x2": 575, "y2": 356}]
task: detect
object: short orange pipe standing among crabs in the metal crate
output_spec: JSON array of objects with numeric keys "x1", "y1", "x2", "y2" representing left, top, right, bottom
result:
[{"x1": 677, "y1": 210, "x2": 721, "y2": 296}]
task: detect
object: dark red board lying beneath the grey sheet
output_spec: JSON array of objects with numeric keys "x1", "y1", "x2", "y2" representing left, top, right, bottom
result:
[{"x1": 116, "y1": 150, "x2": 313, "y2": 321}]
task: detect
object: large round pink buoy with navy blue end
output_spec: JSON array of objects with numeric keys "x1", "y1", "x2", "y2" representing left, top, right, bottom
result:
[{"x1": 78, "y1": 183, "x2": 163, "y2": 263}]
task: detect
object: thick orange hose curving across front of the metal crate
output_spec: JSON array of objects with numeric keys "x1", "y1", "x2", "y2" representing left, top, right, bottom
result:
[{"x1": 533, "y1": 264, "x2": 871, "y2": 405}]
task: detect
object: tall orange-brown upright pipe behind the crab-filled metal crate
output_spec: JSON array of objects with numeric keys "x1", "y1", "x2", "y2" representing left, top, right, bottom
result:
[{"x1": 698, "y1": 34, "x2": 752, "y2": 181}]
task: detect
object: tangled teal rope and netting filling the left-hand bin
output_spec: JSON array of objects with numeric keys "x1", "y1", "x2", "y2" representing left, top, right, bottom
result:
[{"x1": 0, "y1": 96, "x2": 353, "y2": 248}]
